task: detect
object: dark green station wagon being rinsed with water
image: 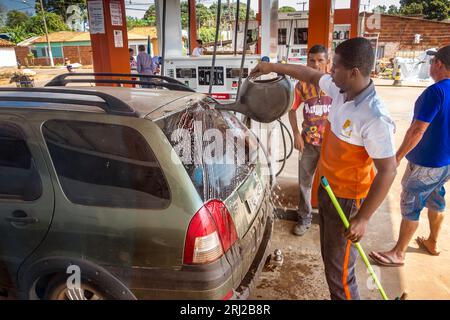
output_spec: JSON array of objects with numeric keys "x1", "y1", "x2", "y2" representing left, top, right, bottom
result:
[{"x1": 0, "y1": 74, "x2": 273, "y2": 300}]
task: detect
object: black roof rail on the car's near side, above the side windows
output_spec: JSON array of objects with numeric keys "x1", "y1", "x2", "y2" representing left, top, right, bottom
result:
[{"x1": 0, "y1": 88, "x2": 138, "y2": 117}]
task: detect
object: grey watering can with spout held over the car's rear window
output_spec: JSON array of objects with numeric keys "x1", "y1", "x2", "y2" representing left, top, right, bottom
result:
[{"x1": 216, "y1": 75, "x2": 293, "y2": 123}]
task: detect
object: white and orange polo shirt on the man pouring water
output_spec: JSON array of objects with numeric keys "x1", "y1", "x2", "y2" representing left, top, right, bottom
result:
[{"x1": 318, "y1": 75, "x2": 395, "y2": 199}]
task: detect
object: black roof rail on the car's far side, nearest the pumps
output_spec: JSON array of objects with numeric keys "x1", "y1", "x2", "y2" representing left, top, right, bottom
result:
[{"x1": 45, "y1": 72, "x2": 195, "y2": 92}]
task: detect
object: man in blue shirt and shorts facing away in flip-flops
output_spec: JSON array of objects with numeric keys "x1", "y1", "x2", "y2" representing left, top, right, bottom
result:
[{"x1": 370, "y1": 45, "x2": 450, "y2": 266}]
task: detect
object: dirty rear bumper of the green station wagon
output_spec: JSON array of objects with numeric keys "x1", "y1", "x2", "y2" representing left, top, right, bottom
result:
[{"x1": 105, "y1": 199, "x2": 274, "y2": 300}]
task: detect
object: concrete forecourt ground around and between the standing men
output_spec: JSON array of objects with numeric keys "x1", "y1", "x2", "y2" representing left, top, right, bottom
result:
[{"x1": 251, "y1": 86, "x2": 450, "y2": 299}]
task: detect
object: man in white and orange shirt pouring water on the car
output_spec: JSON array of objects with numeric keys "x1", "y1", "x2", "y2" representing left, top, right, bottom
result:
[{"x1": 251, "y1": 38, "x2": 397, "y2": 300}]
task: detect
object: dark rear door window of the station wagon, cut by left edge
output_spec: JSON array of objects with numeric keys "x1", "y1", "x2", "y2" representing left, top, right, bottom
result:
[{"x1": 0, "y1": 122, "x2": 42, "y2": 201}]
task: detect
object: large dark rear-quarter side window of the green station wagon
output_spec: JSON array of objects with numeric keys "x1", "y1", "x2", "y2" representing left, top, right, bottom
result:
[{"x1": 42, "y1": 120, "x2": 170, "y2": 209}]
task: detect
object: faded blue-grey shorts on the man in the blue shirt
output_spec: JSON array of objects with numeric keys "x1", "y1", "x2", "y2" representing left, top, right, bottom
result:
[{"x1": 400, "y1": 162, "x2": 450, "y2": 221}]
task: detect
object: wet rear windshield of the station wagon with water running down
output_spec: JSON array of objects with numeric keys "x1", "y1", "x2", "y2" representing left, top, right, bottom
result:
[{"x1": 157, "y1": 98, "x2": 259, "y2": 201}]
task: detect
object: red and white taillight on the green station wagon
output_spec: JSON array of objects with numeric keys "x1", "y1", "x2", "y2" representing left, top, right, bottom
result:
[{"x1": 184, "y1": 200, "x2": 237, "y2": 264}]
